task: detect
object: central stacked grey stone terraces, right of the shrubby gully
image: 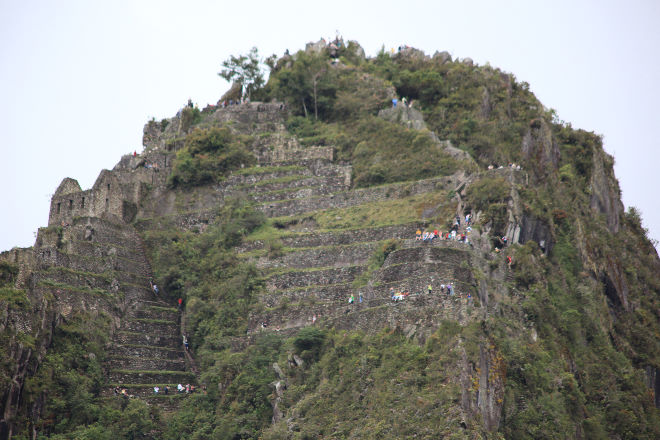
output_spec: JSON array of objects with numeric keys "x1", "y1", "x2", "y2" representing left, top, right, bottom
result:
[{"x1": 135, "y1": 103, "x2": 484, "y2": 339}]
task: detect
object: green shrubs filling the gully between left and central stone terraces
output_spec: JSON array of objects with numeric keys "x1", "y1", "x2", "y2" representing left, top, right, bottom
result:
[{"x1": 146, "y1": 199, "x2": 264, "y2": 340}]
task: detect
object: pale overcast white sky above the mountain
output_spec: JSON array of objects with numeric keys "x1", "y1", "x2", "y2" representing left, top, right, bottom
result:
[{"x1": 0, "y1": 0, "x2": 660, "y2": 251}]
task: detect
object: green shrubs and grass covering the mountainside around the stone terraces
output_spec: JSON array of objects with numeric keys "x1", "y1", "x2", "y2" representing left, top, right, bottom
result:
[{"x1": 5, "y1": 39, "x2": 660, "y2": 439}]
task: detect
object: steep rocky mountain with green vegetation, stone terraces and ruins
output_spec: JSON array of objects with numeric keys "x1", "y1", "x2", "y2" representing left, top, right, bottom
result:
[{"x1": 0, "y1": 42, "x2": 660, "y2": 438}]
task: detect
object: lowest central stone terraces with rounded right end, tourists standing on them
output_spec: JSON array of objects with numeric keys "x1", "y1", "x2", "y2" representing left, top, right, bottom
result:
[{"x1": 245, "y1": 237, "x2": 476, "y2": 332}]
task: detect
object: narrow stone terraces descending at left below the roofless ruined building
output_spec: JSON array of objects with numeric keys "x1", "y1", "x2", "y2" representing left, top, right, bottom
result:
[{"x1": 33, "y1": 217, "x2": 195, "y2": 410}]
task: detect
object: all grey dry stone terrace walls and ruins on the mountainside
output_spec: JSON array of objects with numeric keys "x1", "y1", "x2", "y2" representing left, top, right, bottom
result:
[{"x1": 0, "y1": 97, "x2": 592, "y2": 434}]
